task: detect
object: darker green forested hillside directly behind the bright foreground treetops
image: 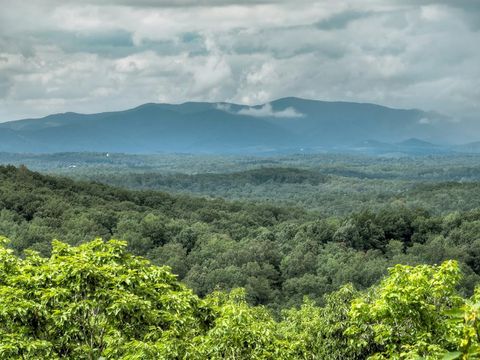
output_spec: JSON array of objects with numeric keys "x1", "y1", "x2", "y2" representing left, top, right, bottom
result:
[{"x1": 0, "y1": 166, "x2": 480, "y2": 309}]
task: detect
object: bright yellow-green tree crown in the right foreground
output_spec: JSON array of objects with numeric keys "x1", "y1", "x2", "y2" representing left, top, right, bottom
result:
[{"x1": 346, "y1": 261, "x2": 462, "y2": 359}]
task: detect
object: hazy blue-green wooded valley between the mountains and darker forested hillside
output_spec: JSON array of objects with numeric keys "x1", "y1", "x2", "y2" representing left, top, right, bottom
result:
[{"x1": 4, "y1": 153, "x2": 480, "y2": 217}]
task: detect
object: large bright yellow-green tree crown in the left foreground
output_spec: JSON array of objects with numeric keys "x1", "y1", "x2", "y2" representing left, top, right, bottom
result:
[{"x1": 0, "y1": 239, "x2": 210, "y2": 359}]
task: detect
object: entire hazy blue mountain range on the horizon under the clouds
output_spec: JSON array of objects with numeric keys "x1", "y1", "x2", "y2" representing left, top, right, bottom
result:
[{"x1": 0, "y1": 97, "x2": 480, "y2": 154}]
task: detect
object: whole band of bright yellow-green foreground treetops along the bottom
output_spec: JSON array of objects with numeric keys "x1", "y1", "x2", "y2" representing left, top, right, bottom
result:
[{"x1": 0, "y1": 239, "x2": 480, "y2": 360}]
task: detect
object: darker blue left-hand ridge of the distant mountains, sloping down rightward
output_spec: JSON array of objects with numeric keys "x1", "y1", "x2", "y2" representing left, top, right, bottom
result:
[{"x1": 0, "y1": 104, "x2": 294, "y2": 153}]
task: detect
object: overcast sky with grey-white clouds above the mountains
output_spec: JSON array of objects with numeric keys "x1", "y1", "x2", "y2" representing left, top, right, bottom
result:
[{"x1": 0, "y1": 0, "x2": 480, "y2": 122}]
